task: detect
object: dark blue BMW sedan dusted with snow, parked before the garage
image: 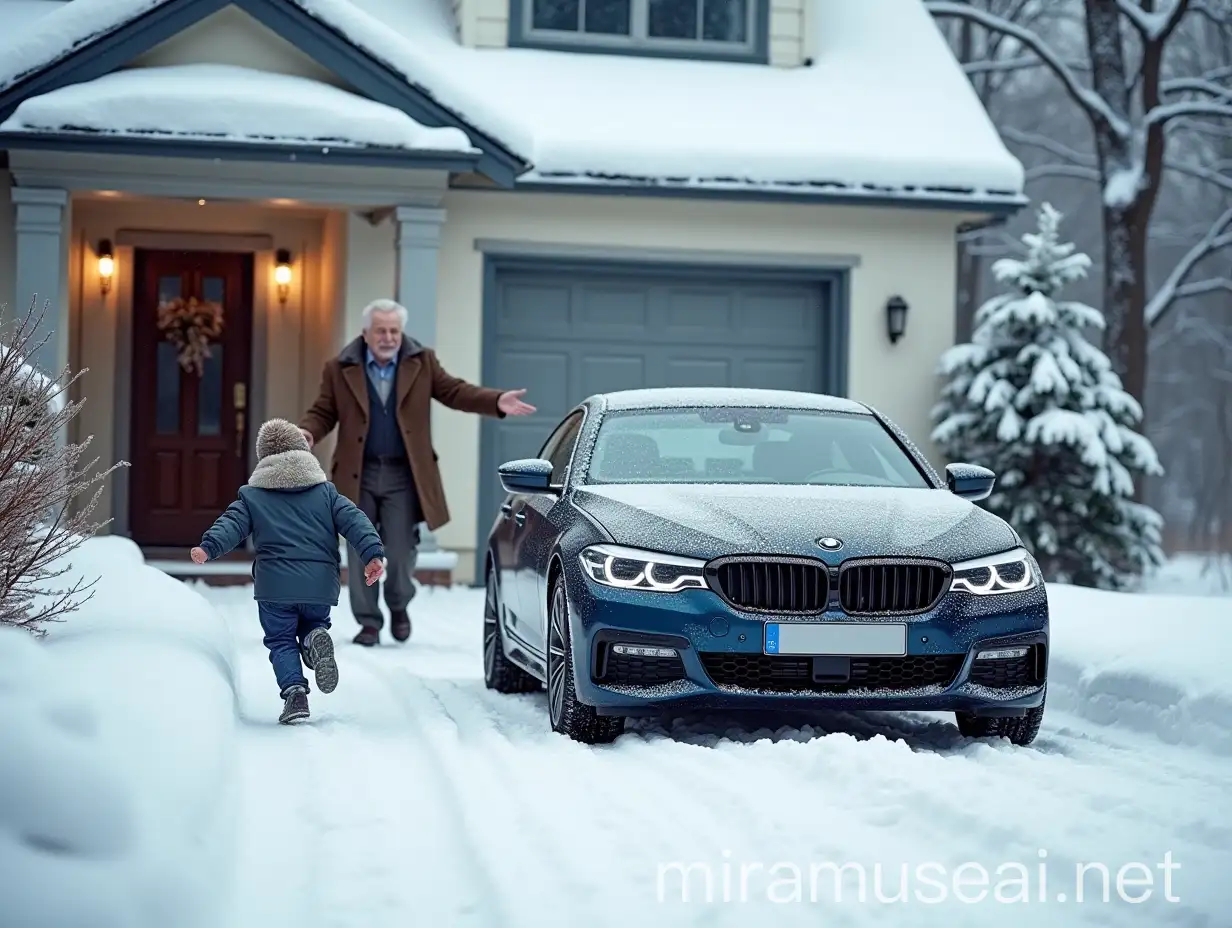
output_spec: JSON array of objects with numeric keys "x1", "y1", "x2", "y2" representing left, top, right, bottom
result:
[{"x1": 483, "y1": 388, "x2": 1048, "y2": 744}]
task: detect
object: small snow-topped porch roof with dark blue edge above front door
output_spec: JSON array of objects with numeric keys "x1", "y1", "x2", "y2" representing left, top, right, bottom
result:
[{"x1": 0, "y1": 64, "x2": 482, "y2": 170}]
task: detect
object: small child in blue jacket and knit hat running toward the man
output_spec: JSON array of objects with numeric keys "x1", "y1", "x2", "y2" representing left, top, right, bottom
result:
[{"x1": 191, "y1": 419, "x2": 384, "y2": 725}]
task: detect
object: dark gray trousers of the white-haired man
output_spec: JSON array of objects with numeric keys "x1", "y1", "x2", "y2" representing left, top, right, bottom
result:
[{"x1": 346, "y1": 461, "x2": 424, "y2": 629}]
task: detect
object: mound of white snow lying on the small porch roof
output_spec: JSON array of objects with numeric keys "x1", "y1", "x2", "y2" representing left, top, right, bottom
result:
[{"x1": 0, "y1": 64, "x2": 478, "y2": 152}]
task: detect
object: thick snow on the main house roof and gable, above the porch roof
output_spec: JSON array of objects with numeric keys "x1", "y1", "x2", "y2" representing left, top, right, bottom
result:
[{"x1": 0, "y1": 0, "x2": 1024, "y2": 203}]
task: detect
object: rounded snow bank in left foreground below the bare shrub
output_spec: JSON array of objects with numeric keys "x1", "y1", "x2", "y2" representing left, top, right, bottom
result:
[{"x1": 0, "y1": 537, "x2": 235, "y2": 928}]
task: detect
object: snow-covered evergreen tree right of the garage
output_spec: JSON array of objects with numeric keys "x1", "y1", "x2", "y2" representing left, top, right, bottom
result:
[{"x1": 933, "y1": 203, "x2": 1163, "y2": 589}]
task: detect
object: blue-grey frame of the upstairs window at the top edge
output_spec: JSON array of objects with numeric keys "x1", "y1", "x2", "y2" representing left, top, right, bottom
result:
[{"x1": 519, "y1": 0, "x2": 765, "y2": 59}]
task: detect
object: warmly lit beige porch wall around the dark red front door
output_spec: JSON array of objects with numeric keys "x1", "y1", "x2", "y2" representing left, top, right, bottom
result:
[{"x1": 69, "y1": 198, "x2": 339, "y2": 527}]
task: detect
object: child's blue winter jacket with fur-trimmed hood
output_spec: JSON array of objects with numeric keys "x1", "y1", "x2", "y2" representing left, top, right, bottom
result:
[{"x1": 201, "y1": 451, "x2": 384, "y2": 605}]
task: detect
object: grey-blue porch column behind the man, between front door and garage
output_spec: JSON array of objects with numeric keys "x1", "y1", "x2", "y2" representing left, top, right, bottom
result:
[{"x1": 394, "y1": 206, "x2": 445, "y2": 551}]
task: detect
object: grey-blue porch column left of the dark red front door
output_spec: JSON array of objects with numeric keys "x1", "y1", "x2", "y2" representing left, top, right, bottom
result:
[{"x1": 12, "y1": 187, "x2": 69, "y2": 377}]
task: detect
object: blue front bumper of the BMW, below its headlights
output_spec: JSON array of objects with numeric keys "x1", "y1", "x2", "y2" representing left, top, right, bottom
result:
[{"x1": 569, "y1": 572, "x2": 1048, "y2": 716}]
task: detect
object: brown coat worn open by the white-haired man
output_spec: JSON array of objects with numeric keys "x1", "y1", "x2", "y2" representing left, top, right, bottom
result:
[{"x1": 299, "y1": 335, "x2": 504, "y2": 530}]
